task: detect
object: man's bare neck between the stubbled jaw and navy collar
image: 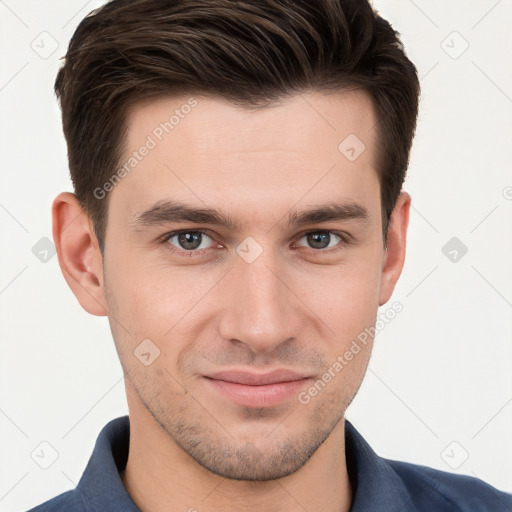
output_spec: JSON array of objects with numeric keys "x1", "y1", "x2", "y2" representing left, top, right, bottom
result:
[{"x1": 120, "y1": 386, "x2": 352, "y2": 512}]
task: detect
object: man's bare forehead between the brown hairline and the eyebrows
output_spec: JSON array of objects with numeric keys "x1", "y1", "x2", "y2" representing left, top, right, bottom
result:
[{"x1": 110, "y1": 91, "x2": 379, "y2": 228}]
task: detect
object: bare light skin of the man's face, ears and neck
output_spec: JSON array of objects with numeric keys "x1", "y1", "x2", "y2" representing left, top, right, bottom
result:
[{"x1": 52, "y1": 91, "x2": 410, "y2": 512}]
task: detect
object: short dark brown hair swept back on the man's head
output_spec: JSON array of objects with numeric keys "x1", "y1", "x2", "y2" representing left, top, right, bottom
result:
[{"x1": 55, "y1": 0, "x2": 420, "y2": 253}]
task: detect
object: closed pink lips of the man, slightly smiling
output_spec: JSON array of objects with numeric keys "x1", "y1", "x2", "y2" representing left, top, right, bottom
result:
[{"x1": 205, "y1": 370, "x2": 310, "y2": 408}]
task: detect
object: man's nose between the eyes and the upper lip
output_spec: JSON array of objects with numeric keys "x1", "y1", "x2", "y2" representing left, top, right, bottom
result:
[{"x1": 219, "y1": 251, "x2": 305, "y2": 354}]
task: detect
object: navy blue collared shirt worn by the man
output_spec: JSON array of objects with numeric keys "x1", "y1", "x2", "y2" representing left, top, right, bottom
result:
[{"x1": 29, "y1": 416, "x2": 512, "y2": 512}]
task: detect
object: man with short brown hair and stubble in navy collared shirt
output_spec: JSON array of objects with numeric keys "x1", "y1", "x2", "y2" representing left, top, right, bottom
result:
[{"x1": 27, "y1": 0, "x2": 512, "y2": 512}]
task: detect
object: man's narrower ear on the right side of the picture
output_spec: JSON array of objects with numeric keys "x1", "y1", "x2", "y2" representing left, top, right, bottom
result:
[{"x1": 379, "y1": 191, "x2": 411, "y2": 306}]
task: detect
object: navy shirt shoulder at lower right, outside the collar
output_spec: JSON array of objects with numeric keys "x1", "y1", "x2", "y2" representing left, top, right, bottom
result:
[{"x1": 386, "y1": 460, "x2": 512, "y2": 512}]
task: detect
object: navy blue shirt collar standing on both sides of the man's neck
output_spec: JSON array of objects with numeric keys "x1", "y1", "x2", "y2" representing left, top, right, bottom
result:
[{"x1": 77, "y1": 416, "x2": 413, "y2": 512}]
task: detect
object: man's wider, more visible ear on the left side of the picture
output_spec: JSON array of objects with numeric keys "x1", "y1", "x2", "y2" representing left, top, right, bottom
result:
[{"x1": 52, "y1": 192, "x2": 107, "y2": 316}]
